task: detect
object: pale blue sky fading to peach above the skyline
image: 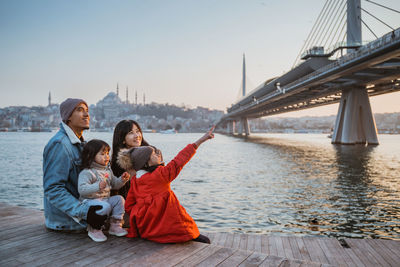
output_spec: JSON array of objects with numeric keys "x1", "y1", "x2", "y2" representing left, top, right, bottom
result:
[{"x1": 0, "y1": 0, "x2": 400, "y2": 117}]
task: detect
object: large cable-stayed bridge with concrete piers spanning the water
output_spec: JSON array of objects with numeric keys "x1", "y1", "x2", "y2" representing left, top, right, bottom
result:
[{"x1": 218, "y1": 0, "x2": 400, "y2": 145}]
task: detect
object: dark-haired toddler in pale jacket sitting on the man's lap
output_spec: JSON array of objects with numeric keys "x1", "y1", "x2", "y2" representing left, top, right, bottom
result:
[{"x1": 78, "y1": 139, "x2": 130, "y2": 242}]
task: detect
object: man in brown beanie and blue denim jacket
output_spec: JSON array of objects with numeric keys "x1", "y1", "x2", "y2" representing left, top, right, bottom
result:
[{"x1": 43, "y1": 98, "x2": 107, "y2": 231}]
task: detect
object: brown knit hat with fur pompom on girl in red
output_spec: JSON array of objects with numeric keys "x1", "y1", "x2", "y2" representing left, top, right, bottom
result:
[{"x1": 117, "y1": 146, "x2": 153, "y2": 171}]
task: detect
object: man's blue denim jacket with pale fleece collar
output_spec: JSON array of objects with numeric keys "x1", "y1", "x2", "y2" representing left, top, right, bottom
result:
[{"x1": 43, "y1": 123, "x2": 89, "y2": 230}]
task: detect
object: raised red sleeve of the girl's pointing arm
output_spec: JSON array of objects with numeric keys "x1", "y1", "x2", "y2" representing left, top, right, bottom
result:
[{"x1": 156, "y1": 144, "x2": 197, "y2": 182}]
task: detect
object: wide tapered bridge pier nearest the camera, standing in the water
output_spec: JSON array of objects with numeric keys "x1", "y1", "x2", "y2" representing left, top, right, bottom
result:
[{"x1": 332, "y1": 88, "x2": 379, "y2": 145}]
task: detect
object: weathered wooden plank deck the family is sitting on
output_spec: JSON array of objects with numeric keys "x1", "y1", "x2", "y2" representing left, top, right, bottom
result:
[{"x1": 0, "y1": 203, "x2": 400, "y2": 267}]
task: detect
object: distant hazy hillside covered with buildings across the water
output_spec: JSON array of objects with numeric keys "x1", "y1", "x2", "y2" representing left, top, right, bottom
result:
[{"x1": 0, "y1": 91, "x2": 400, "y2": 134}]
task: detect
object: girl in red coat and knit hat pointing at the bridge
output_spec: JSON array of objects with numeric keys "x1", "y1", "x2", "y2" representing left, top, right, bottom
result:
[{"x1": 118, "y1": 127, "x2": 214, "y2": 243}]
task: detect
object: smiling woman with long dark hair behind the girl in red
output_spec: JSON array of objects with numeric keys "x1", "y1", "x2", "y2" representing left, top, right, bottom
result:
[{"x1": 111, "y1": 120, "x2": 149, "y2": 199}]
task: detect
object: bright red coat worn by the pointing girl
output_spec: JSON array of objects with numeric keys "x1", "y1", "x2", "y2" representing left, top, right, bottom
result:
[{"x1": 125, "y1": 144, "x2": 200, "y2": 243}]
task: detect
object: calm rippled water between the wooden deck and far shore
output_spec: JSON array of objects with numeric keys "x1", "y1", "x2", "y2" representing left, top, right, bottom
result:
[{"x1": 0, "y1": 132, "x2": 400, "y2": 240}]
